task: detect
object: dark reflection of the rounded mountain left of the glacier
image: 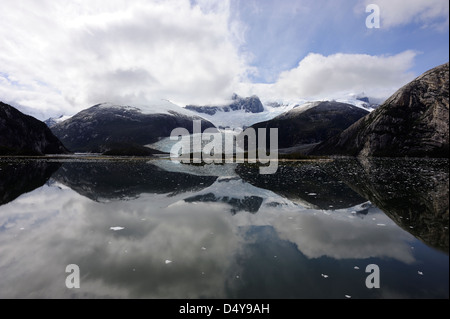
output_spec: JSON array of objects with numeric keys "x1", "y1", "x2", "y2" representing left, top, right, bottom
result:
[{"x1": 52, "y1": 161, "x2": 217, "y2": 201}]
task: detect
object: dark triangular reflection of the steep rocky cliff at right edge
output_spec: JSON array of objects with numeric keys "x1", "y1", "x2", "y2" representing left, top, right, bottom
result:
[{"x1": 329, "y1": 158, "x2": 449, "y2": 252}]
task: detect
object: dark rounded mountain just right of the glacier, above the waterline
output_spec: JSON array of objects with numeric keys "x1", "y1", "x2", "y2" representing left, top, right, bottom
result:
[{"x1": 252, "y1": 101, "x2": 369, "y2": 148}]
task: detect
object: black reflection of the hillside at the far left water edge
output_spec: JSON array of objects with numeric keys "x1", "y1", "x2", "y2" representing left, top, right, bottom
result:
[{"x1": 0, "y1": 160, "x2": 61, "y2": 205}]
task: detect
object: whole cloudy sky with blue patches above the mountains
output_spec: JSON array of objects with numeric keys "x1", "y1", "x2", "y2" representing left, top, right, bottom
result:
[{"x1": 0, "y1": 0, "x2": 449, "y2": 119}]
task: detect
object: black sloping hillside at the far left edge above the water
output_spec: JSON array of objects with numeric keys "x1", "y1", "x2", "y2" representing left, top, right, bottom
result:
[{"x1": 0, "y1": 102, "x2": 68, "y2": 155}]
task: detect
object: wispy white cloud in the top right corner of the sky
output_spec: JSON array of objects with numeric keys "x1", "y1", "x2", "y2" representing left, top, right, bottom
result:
[{"x1": 365, "y1": 0, "x2": 449, "y2": 30}]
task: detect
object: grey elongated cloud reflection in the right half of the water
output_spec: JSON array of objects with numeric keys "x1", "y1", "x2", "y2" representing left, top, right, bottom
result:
[{"x1": 235, "y1": 206, "x2": 414, "y2": 264}]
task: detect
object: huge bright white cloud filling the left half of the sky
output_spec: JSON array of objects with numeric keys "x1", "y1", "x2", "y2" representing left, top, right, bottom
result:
[{"x1": 0, "y1": 0, "x2": 247, "y2": 117}]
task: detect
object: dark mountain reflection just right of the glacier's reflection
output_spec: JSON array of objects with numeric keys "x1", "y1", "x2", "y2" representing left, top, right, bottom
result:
[{"x1": 236, "y1": 163, "x2": 367, "y2": 210}]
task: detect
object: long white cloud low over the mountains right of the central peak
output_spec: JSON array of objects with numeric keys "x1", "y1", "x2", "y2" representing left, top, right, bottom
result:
[{"x1": 243, "y1": 51, "x2": 417, "y2": 99}]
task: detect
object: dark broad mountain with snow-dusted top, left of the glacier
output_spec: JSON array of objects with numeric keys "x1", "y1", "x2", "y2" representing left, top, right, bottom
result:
[{"x1": 51, "y1": 104, "x2": 214, "y2": 153}]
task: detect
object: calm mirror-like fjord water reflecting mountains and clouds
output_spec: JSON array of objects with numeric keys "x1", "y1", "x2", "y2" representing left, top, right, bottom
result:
[{"x1": 0, "y1": 158, "x2": 449, "y2": 299}]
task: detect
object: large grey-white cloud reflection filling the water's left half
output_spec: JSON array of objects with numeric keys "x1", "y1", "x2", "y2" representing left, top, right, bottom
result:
[{"x1": 0, "y1": 187, "x2": 243, "y2": 298}]
